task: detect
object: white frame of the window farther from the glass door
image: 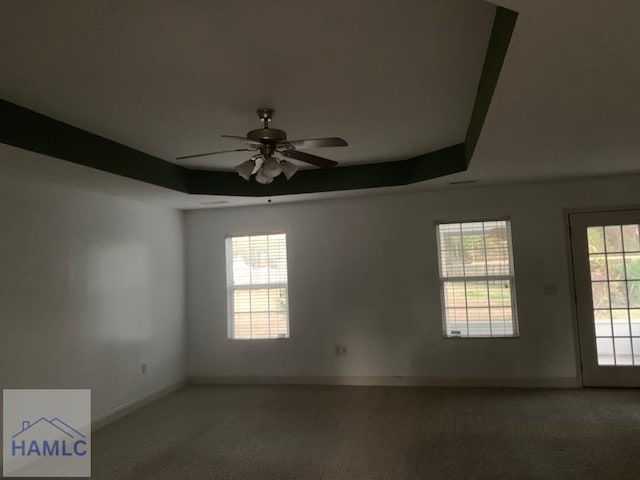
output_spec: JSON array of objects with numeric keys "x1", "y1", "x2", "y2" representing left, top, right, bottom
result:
[{"x1": 224, "y1": 230, "x2": 291, "y2": 342}]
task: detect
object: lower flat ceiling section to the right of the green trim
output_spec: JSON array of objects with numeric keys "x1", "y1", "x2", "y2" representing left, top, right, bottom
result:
[{"x1": 464, "y1": 0, "x2": 640, "y2": 186}]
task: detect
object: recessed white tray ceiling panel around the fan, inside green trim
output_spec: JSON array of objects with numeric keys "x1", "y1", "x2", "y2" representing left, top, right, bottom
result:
[{"x1": 0, "y1": 0, "x2": 495, "y2": 169}]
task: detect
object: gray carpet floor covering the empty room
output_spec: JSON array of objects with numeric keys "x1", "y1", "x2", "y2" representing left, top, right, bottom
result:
[{"x1": 57, "y1": 386, "x2": 640, "y2": 480}]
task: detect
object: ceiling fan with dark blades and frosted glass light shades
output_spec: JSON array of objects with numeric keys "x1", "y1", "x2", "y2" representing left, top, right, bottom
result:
[{"x1": 176, "y1": 108, "x2": 348, "y2": 185}]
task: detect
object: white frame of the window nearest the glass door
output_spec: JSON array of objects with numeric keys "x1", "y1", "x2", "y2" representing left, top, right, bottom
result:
[{"x1": 434, "y1": 216, "x2": 520, "y2": 340}]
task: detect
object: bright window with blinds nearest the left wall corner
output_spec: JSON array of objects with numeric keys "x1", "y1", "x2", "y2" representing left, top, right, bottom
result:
[{"x1": 226, "y1": 233, "x2": 289, "y2": 339}]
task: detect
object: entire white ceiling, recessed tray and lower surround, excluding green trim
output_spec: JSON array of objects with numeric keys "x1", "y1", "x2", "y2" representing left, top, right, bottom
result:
[{"x1": 0, "y1": 0, "x2": 640, "y2": 208}]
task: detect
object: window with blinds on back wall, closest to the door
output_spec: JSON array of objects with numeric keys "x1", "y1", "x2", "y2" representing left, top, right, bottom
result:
[{"x1": 437, "y1": 220, "x2": 518, "y2": 337}]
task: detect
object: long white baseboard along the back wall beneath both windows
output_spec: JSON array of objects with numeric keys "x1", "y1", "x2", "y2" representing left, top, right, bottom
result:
[{"x1": 189, "y1": 375, "x2": 581, "y2": 388}]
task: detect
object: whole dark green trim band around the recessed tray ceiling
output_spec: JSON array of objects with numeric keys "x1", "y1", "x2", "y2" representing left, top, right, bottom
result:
[{"x1": 0, "y1": 7, "x2": 518, "y2": 197}]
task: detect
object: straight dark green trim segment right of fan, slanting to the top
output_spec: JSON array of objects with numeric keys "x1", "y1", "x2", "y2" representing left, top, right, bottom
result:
[{"x1": 465, "y1": 7, "x2": 518, "y2": 164}]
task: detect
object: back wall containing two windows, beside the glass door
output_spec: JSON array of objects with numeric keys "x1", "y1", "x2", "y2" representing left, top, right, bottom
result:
[{"x1": 186, "y1": 177, "x2": 640, "y2": 385}]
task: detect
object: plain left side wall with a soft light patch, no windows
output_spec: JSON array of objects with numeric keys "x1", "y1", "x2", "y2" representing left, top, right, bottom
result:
[{"x1": 0, "y1": 176, "x2": 186, "y2": 424}]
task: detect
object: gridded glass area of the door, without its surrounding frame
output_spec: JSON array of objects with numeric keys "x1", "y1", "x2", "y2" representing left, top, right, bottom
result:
[{"x1": 587, "y1": 224, "x2": 640, "y2": 366}]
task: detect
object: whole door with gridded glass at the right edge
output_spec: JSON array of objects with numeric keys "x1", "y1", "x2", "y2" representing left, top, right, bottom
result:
[{"x1": 569, "y1": 210, "x2": 640, "y2": 387}]
